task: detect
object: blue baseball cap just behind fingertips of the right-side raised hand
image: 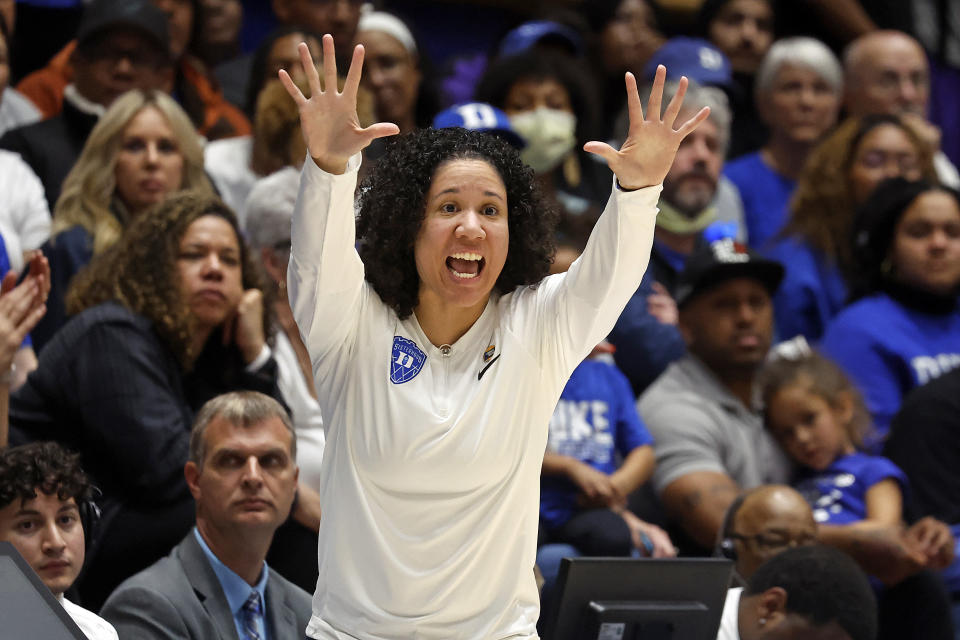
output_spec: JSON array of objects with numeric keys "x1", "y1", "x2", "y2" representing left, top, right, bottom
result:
[{"x1": 643, "y1": 36, "x2": 733, "y2": 89}]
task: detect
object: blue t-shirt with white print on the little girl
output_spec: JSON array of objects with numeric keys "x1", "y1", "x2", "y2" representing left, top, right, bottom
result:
[{"x1": 794, "y1": 451, "x2": 908, "y2": 524}]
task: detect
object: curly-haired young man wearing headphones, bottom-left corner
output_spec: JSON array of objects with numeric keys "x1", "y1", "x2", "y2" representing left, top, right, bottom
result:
[{"x1": 0, "y1": 442, "x2": 117, "y2": 640}]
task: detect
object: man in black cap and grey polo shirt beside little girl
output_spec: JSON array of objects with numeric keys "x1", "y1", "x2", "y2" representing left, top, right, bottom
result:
[{"x1": 638, "y1": 240, "x2": 790, "y2": 551}]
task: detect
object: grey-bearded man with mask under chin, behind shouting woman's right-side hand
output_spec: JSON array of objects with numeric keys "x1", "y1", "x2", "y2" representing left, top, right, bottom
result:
[{"x1": 609, "y1": 73, "x2": 735, "y2": 395}]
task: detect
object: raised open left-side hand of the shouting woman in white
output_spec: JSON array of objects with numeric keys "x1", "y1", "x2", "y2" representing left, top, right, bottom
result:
[{"x1": 279, "y1": 34, "x2": 400, "y2": 173}]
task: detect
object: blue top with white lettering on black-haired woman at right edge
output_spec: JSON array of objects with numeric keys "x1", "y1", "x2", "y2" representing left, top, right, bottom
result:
[{"x1": 821, "y1": 293, "x2": 960, "y2": 452}]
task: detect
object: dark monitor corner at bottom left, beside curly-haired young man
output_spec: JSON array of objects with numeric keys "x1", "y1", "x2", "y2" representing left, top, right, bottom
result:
[{"x1": 0, "y1": 542, "x2": 87, "y2": 640}]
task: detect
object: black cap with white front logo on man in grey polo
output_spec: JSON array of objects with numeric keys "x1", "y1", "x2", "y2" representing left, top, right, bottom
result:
[{"x1": 675, "y1": 238, "x2": 784, "y2": 307}]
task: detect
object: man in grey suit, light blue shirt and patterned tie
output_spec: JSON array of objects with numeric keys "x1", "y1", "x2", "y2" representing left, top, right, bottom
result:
[{"x1": 101, "y1": 391, "x2": 310, "y2": 640}]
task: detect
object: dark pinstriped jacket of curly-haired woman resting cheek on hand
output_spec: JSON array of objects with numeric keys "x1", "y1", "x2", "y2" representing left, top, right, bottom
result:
[{"x1": 10, "y1": 302, "x2": 280, "y2": 503}]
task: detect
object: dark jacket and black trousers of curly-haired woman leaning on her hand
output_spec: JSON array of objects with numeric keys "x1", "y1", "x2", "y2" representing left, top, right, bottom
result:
[{"x1": 10, "y1": 302, "x2": 280, "y2": 610}]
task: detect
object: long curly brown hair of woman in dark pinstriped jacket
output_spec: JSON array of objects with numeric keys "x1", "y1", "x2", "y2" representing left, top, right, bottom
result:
[{"x1": 67, "y1": 191, "x2": 273, "y2": 371}]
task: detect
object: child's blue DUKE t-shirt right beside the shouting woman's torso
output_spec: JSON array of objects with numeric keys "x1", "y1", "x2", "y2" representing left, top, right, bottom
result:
[{"x1": 540, "y1": 360, "x2": 653, "y2": 528}]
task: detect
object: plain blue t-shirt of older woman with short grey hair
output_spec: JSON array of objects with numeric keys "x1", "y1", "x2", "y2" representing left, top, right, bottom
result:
[{"x1": 723, "y1": 151, "x2": 797, "y2": 248}]
